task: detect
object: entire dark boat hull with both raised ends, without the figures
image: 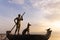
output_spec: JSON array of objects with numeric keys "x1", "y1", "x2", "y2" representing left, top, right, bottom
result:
[{"x1": 6, "y1": 31, "x2": 51, "y2": 40}]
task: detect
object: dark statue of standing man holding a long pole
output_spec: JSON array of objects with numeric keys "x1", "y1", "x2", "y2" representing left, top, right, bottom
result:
[{"x1": 14, "y1": 13, "x2": 25, "y2": 34}]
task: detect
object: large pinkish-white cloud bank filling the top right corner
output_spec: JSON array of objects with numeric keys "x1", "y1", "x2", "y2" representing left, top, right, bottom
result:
[{"x1": 31, "y1": 0, "x2": 60, "y2": 11}]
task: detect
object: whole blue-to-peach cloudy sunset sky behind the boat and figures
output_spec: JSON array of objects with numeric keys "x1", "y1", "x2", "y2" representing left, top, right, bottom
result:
[{"x1": 0, "y1": 0, "x2": 60, "y2": 33}]
